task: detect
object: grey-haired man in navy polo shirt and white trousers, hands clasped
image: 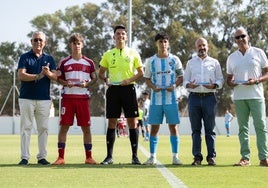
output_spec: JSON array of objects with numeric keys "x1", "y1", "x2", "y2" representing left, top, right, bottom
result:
[{"x1": 18, "y1": 31, "x2": 57, "y2": 165}]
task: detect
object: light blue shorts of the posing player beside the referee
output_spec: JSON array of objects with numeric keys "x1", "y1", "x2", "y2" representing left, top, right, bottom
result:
[{"x1": 148, "y1": 104, "x2": 180, "y2": 125}]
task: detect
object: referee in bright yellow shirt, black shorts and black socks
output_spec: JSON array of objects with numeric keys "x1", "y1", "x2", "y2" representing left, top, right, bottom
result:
[{"x1": 99, "y1": 25, "x2": 143, "y2": 165}]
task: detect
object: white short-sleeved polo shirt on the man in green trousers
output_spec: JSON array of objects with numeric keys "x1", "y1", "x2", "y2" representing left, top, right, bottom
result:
[{"x1": 227, "y1": 47, "x2": 268, "y2": 100}]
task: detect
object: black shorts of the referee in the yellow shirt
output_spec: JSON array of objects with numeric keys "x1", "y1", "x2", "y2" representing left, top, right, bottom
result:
[{"x1": 106, "y1": 84, "x2": 139, "y2": 118}]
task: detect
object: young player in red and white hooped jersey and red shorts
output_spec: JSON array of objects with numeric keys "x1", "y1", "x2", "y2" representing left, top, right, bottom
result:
[{"x1": 53, "y1": 33, "x2": 97, "y2": 165}]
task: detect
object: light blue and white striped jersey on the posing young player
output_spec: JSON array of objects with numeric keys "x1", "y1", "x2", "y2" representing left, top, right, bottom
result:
[{"x1": 144, "y1": 54, "x2": 183, "y2": 105}]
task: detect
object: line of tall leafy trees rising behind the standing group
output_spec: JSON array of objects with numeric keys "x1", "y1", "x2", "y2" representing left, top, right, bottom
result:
[{"x1": 0, "y1": 0, "x2": 268, "y2": 116}]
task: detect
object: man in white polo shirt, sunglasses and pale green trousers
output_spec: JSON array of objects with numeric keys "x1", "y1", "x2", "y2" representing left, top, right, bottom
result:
[{"x1": 227, "y1": 28, "x2": 268, "y2": 166}]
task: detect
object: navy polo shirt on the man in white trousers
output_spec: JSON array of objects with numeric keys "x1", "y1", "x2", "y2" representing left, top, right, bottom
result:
[{"x1": 18, "y1": 50, "x2": 56, "y2": 100}]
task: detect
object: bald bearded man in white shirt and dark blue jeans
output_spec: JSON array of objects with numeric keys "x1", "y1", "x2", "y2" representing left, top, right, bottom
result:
[{"x1": 183, "y1": 38, "x2": 223, "y2": 166}]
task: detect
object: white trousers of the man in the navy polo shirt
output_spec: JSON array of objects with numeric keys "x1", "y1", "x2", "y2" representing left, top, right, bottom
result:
[{"x1": 19, "y1": 99, "x2": 51, "y2": 160}]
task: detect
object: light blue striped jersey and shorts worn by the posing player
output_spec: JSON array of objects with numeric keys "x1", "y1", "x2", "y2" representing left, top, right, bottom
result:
[{"x1": 144, "y1": 54, "x2": 183, "y2": 125}]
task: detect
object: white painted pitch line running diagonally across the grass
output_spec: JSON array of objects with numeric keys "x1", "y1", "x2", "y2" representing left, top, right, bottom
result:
[{"x1": 139, "y1": 144, "x2": 187, "y2": 188}]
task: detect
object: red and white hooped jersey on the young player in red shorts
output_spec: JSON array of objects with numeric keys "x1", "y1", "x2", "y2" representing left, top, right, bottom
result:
[{"x1": 57, "y1": 55, "x2": 95, "y2": 98}]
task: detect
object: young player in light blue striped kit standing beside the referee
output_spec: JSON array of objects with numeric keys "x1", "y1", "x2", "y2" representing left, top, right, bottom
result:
[{"x1": 144, "y1": 33, "x2": 183, "y2": 165}]
